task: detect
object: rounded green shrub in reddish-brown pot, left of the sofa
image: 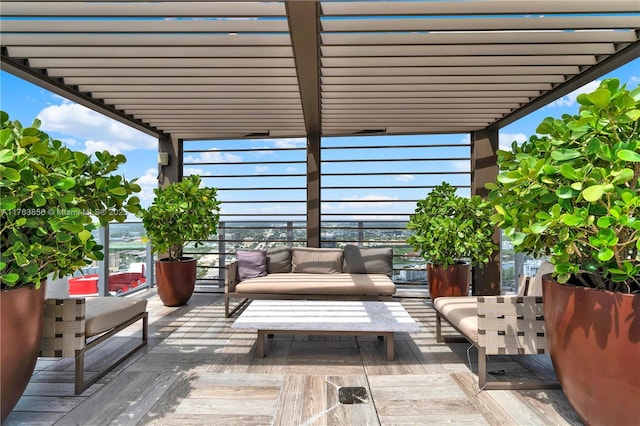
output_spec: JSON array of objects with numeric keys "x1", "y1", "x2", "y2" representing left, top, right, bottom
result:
[{"x1": 139, "y1": 175, "x2": 220, "y2": 306}]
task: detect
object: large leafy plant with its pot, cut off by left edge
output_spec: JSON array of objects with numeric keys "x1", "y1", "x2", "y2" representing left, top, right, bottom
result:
[{"x1": 0, "y1": 111, "x2": 140, "y2": 420}]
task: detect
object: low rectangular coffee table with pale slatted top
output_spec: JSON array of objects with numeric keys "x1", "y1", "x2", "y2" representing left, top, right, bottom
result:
[{"x1": 231, "y1": 300, "x2": 420, "y2": 361}]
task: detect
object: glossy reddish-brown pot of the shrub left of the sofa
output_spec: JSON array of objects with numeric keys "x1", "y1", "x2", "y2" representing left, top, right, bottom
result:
[{"x1": 156, "y1": 257, "x2": 197, "y2": 306}]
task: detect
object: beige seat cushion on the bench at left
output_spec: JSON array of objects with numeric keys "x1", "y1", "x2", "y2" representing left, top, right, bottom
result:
[{"x1": 85, "y1": 297, "x2": 147, "y2": 337}]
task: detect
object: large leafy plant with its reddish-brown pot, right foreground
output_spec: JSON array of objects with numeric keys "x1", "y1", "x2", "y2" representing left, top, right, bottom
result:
[{"x1": 487, "y1": 79, "x2": 640, "y2": 425}]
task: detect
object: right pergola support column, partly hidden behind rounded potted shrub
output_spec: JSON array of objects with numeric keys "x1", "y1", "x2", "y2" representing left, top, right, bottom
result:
[{"x1": 471, "y1": 129, "x2": 501, "y2": 296}]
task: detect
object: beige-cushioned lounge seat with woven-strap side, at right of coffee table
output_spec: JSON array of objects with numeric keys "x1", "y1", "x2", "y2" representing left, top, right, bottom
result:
[{"x1": 433, "y1": 262, "x2": 559, "y2": 390}]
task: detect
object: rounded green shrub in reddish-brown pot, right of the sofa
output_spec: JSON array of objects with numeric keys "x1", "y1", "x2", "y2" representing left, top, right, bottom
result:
[{"x1": 407, "y1": 182, "x2": 498, "y2": 300}]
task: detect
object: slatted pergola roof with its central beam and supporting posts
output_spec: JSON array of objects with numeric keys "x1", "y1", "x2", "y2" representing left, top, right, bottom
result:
[{"x1": 0, "y1": 0, "x2": 640, "y2": 294}]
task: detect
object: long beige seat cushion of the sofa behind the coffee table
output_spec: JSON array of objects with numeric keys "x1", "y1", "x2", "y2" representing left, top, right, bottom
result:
[{"x1": 235, "y1": 272, "x2": 396, "y2": 296}]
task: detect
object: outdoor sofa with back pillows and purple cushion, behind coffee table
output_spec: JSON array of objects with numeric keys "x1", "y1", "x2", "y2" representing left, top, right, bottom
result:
[{"x1": 224, "y1": 245, "x2": 396, "y2": 318}]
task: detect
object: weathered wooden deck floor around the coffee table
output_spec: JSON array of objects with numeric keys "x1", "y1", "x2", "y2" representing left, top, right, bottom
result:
[{"x1": 3, "y1": 290, "x2": 581, "y2": 425}]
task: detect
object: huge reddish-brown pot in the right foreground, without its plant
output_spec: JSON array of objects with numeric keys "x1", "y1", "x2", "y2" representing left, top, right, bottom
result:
[{"x1": 542, "y1": 275, "x2": 640, "y2": 426}]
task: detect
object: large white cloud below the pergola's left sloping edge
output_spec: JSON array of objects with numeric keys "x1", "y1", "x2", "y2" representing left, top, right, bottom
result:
[{"x1": 38, "y1": 101, "x2": 158, "y2": 153}]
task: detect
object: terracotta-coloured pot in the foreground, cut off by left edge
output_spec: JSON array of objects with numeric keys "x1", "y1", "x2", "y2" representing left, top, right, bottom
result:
[{"x1": 0, "y1": 282, "x2": 46, "y2": 421}]
